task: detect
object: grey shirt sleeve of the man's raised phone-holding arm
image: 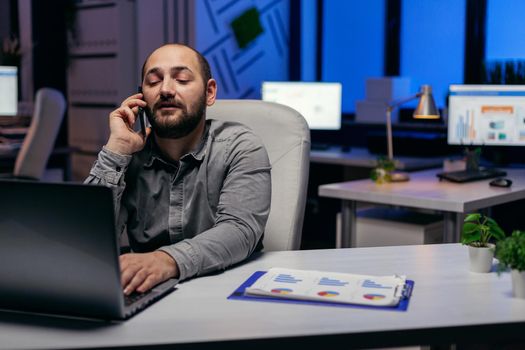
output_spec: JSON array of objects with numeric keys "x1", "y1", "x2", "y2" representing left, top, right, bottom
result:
[{"x1": 84, "y1": 147, "x2": 132, "y2": 233}]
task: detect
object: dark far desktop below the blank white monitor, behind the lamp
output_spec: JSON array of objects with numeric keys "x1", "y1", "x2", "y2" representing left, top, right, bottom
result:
[{"x1": 310, "y1": 147, "x2": 444, "y2": 171}]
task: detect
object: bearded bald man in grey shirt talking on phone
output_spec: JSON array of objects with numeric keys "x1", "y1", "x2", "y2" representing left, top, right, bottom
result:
[{"x1": 86, "y1": 44, "x2": 271, "y2": 294}]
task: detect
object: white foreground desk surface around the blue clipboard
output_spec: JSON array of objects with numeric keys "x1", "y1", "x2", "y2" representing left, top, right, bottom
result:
[{"x1": 0, "y1": 244, "x2": 525, "y2": 349}]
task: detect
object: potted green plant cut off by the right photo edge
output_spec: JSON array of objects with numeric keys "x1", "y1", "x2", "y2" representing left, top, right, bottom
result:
[{"x1": 496, "y1": 230, "x2": 525, "y2": 299}]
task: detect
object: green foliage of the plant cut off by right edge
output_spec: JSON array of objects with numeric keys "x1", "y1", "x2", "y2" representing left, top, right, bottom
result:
[{"x1": 496, "y1": 230, "x2": 525, "y2": 272}]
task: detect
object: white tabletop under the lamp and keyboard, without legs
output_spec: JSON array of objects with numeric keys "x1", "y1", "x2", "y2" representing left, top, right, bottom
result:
[{"x1": 319, "y1": 169, "x2": 525, "y2": 213}]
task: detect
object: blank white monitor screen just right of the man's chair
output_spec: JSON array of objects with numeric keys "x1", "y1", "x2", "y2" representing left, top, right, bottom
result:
[{"x1": 262, "y1": 82, "x2": 342, "y2": 130}]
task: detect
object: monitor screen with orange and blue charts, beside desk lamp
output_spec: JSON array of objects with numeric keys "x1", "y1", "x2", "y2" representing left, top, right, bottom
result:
[{"x1": 447, "y1": 85, "x2": 525, "y2": 146}]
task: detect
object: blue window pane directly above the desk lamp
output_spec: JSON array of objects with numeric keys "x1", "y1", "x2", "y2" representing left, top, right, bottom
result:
[{"x1": 400, "y1": 0, "x2": 464, "y2": 108}]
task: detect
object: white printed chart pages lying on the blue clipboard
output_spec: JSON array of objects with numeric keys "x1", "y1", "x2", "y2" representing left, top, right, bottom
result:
[{"x1": 245, "y1": 268, "x2": 406, "y2": 306}]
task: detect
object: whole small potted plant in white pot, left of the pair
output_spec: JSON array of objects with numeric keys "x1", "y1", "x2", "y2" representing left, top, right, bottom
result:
[{"x1": 461, "y1": 213, "x2": 505, "y2": 272}]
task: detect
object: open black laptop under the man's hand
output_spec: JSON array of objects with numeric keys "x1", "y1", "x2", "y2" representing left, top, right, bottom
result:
[{"x1": 0, "y1": 180, "x2": 178, "y2": 320}]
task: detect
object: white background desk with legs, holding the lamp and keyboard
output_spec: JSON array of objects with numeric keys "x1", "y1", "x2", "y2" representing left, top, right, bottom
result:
[{"x1": 319, "y1": 169, "x2": 525, "y2": 247}]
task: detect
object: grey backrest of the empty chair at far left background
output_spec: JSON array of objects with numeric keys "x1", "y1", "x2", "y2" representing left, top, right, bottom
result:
[{"x1": 13, "y1": 88, "x2": 66, "y2": 179}]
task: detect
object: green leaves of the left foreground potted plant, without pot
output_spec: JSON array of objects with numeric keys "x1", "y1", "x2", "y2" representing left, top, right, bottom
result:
[{"x1": 461, "y1": 213, "x2": 505, "y2": 247}]
